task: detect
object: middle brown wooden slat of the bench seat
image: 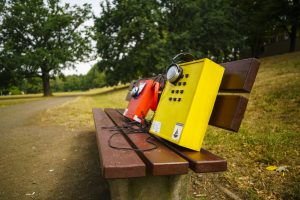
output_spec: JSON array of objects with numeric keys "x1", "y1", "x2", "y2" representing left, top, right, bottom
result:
[{"x1": 104, "y1": 109, "x2": 189, "y2": 175}]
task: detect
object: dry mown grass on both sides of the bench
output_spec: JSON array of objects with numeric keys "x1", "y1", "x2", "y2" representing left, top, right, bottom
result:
[{"x1": 34, "y1": 52, "x2": 300, "y2": 199}]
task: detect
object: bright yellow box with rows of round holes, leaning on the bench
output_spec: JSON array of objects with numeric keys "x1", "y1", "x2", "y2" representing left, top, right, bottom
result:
[{"x1": 150, "y1": 58, "x2": 224, "y2": 151}]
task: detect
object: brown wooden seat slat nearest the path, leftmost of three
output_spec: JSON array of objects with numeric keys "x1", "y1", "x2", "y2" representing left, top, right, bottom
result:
[{"x1": 93, "y1": 109, "x2": 146, "y2": 178}]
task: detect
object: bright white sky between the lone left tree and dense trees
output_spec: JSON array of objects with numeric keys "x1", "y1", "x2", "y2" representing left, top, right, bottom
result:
[{"x1": 61, "y1": 0, "x2": 101, "y2": 75}]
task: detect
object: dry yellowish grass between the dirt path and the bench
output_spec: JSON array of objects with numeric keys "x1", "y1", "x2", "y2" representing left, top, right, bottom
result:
[{"x1": 37, "y1": 88, "x2": 128, "y2": 131}]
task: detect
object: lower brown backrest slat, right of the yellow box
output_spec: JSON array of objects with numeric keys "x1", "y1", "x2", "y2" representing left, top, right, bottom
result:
[{"x1": 209, "y1": 95, "x2": 248, "y2": 132}]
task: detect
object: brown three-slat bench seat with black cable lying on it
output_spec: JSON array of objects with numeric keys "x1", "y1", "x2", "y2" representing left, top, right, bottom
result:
[{"x1": 93, "y1": 109, "x2": 227, "y2": 179}]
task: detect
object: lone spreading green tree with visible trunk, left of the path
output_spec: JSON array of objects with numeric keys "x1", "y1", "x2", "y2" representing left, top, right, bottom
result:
[{"x1": 0, "y1": 0, "x2": 91, "y2": 96}]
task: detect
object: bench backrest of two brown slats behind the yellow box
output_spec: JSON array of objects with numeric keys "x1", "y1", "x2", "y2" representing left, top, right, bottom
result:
[{"x1": 126, "y1": 58, "x2": 260, "y2": 132}]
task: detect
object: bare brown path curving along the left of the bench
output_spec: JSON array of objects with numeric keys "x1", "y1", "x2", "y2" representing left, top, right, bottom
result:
[{"x1": 0, "y1": 97, "x2": 109, "y2": 200}]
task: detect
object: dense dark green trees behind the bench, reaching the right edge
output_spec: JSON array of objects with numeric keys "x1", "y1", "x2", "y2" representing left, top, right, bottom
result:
[{"x1": 95, "y1": 0, "x2": 300, "y2": 85}]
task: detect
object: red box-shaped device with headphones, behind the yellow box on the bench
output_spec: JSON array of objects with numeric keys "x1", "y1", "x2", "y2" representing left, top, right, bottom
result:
[{"x1": 123, "y1": 79, "x2": 160, "y2": 123}]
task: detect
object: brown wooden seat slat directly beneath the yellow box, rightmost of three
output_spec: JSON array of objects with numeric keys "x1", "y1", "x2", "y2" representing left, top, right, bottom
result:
[{"x1": 155, "y1": 136, "x2": 227, "y2": 173}]
